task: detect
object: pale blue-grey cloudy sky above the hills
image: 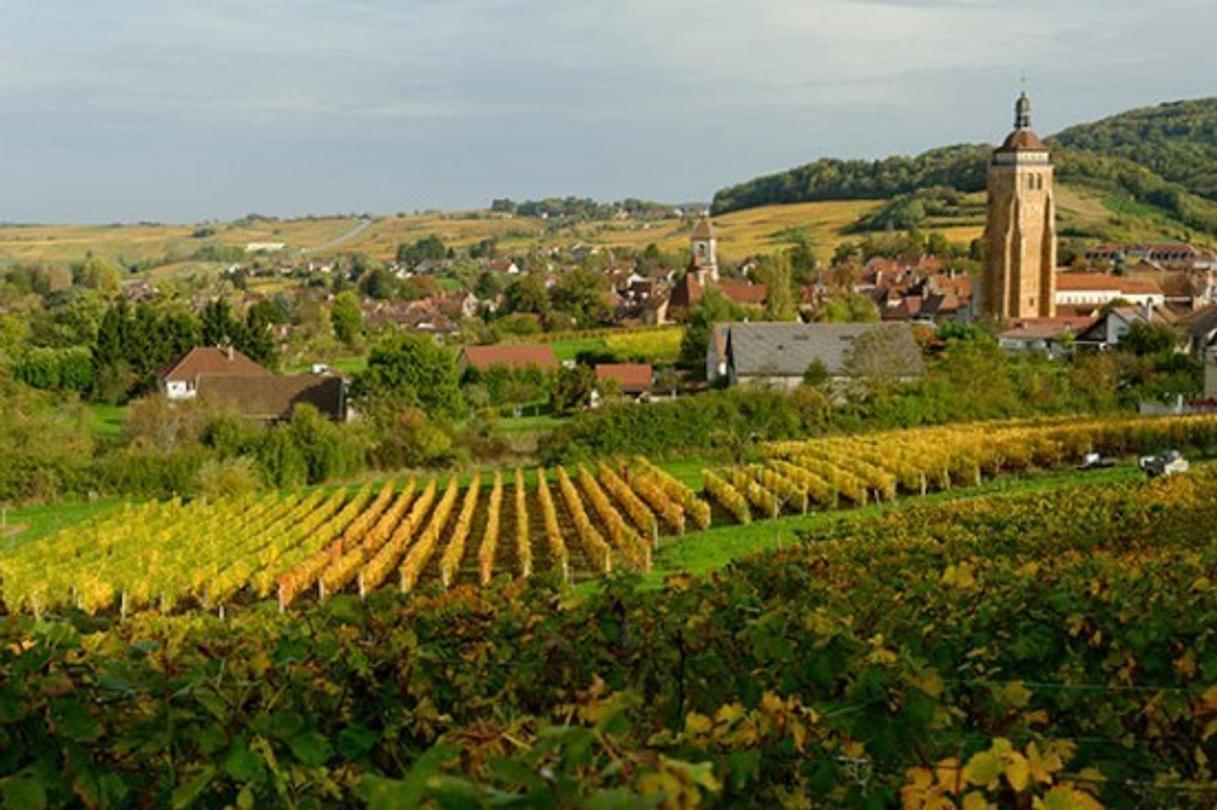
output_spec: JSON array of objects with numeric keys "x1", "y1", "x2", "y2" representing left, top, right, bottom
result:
[{"x1": 0, "y1": 0, "x2": 1217, "y2": 223}]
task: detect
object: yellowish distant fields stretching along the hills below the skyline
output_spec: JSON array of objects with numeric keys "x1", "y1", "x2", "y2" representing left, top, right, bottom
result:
[{"x1": 7, "y1": 185, "x2": 1213, "y2": 271}]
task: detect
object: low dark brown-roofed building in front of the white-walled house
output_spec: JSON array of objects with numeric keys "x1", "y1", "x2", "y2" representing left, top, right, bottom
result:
[{"x1": 197, "y1": 373, "x2": 347, "y2": 422}]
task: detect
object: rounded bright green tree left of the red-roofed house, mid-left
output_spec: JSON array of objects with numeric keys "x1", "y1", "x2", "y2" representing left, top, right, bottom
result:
[{"x1": 354, "y1": 332, "x2": 462, "y2": 416}]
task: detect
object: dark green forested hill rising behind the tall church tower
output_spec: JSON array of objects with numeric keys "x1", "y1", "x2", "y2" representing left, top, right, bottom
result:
[{"x1": 713, "y1": 99, "x2": 1217, "y2": 235}]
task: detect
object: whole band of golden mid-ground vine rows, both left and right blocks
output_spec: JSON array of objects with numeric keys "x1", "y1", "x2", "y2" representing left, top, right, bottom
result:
[{"x1": 0, "y1": 416, "x2": 1217, "y2": 615}]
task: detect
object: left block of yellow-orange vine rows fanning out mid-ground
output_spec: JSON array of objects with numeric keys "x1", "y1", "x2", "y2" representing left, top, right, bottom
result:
[{"x1": 0, "y1": 459, "x2": 710, "y2": 615}]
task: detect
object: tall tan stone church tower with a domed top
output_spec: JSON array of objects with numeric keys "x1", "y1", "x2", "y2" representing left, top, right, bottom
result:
[{"x1": 980, "y1": 92, "x2": 1056, "y2": 321}]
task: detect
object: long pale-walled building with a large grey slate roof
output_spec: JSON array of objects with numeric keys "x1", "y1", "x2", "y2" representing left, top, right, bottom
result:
[{"x1": 707, "y1": 322, "x2": 925, "y2": 388}]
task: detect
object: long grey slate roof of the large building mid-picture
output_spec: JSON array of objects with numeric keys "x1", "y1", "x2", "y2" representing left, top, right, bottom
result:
[{"x1": 728, "y1": 324, "x2": 925, "y2": 377}]
